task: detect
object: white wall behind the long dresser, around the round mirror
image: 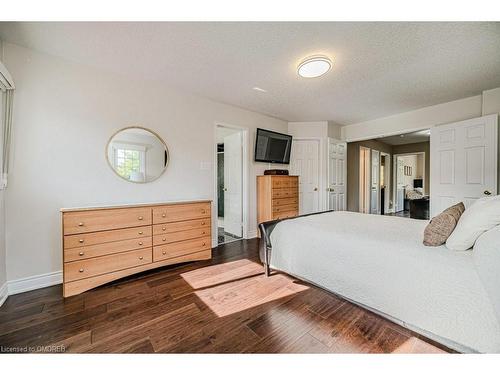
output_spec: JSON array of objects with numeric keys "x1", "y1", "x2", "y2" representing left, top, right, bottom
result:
[{"x1": 4, "y1": 44, "x2": 287, "y2": 280}]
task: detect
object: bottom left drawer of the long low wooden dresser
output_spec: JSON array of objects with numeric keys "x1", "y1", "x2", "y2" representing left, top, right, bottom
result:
[{"x1": 64, "y1": 248, "x2": 152, "y2": 282}]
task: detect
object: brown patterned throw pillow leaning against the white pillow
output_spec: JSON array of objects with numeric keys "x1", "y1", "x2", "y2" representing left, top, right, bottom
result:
[{"x1": 424, "y1": 202, "x2": 465, "y2": 246}]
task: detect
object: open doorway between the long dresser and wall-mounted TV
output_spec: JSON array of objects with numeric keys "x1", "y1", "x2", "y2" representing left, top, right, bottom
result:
[{"x1": 216, "y1": 125, "x2": 245, "y2": 245}]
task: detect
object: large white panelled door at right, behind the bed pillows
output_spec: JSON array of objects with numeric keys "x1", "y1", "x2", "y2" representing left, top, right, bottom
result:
[{"x1": 430, "y1": 114, "x2": 498, "y2": 216}]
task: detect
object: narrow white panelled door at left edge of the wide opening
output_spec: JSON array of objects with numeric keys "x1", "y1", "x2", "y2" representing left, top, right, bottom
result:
[{"x1": 327, "y1": 138, "x2": 347, "y2": 211}]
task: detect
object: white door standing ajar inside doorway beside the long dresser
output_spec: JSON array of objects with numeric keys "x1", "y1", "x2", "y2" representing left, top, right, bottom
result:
[{"x1": 224, "y1": 132, "x2": 243, "y2": 237}]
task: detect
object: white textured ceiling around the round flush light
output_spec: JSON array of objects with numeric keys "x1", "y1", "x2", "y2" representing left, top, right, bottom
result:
[{"x1": 0, "y1": 22, "x2": 500, "y2": 124}]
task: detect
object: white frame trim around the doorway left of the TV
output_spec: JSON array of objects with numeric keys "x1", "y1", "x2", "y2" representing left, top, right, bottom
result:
[{"x1": 212, "y1": 121, "x2": 249, "y2": 248}]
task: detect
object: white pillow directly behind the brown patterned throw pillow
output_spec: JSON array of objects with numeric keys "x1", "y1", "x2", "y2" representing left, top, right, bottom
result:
[{"x1": 446, "y1": 195, "x2": 500, "y2": 250}]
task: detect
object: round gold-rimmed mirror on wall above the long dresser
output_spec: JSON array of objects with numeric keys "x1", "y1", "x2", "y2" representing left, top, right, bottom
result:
[{"x1": 106, "y1": 127, "x2": 169, "y2": 183}]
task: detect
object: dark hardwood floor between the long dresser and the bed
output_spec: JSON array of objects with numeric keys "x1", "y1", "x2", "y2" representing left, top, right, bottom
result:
[{"x1": 0, "y1": 239, "x2": 448, "y2": 353}]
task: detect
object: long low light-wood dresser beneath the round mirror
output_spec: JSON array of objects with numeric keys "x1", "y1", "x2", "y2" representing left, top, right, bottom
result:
[{"x1": 61, "y1": 201, "x2": 212, "y2": 297}]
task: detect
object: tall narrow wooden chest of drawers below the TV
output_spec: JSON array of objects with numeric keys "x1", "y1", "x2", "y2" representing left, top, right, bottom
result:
[{"x1": 257, "y1": 175, "x2": 299, "y2": 229}]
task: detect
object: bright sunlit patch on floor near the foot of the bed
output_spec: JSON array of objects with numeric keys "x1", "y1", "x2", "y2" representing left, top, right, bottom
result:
[{"x1": 181, "y1": 259, "x2": 309, "y2": 317}]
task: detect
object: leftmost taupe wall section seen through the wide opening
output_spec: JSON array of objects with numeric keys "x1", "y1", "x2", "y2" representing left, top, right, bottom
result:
[{"x1": 347, "y1": 140, "x2": 392, "y2": 212}]
